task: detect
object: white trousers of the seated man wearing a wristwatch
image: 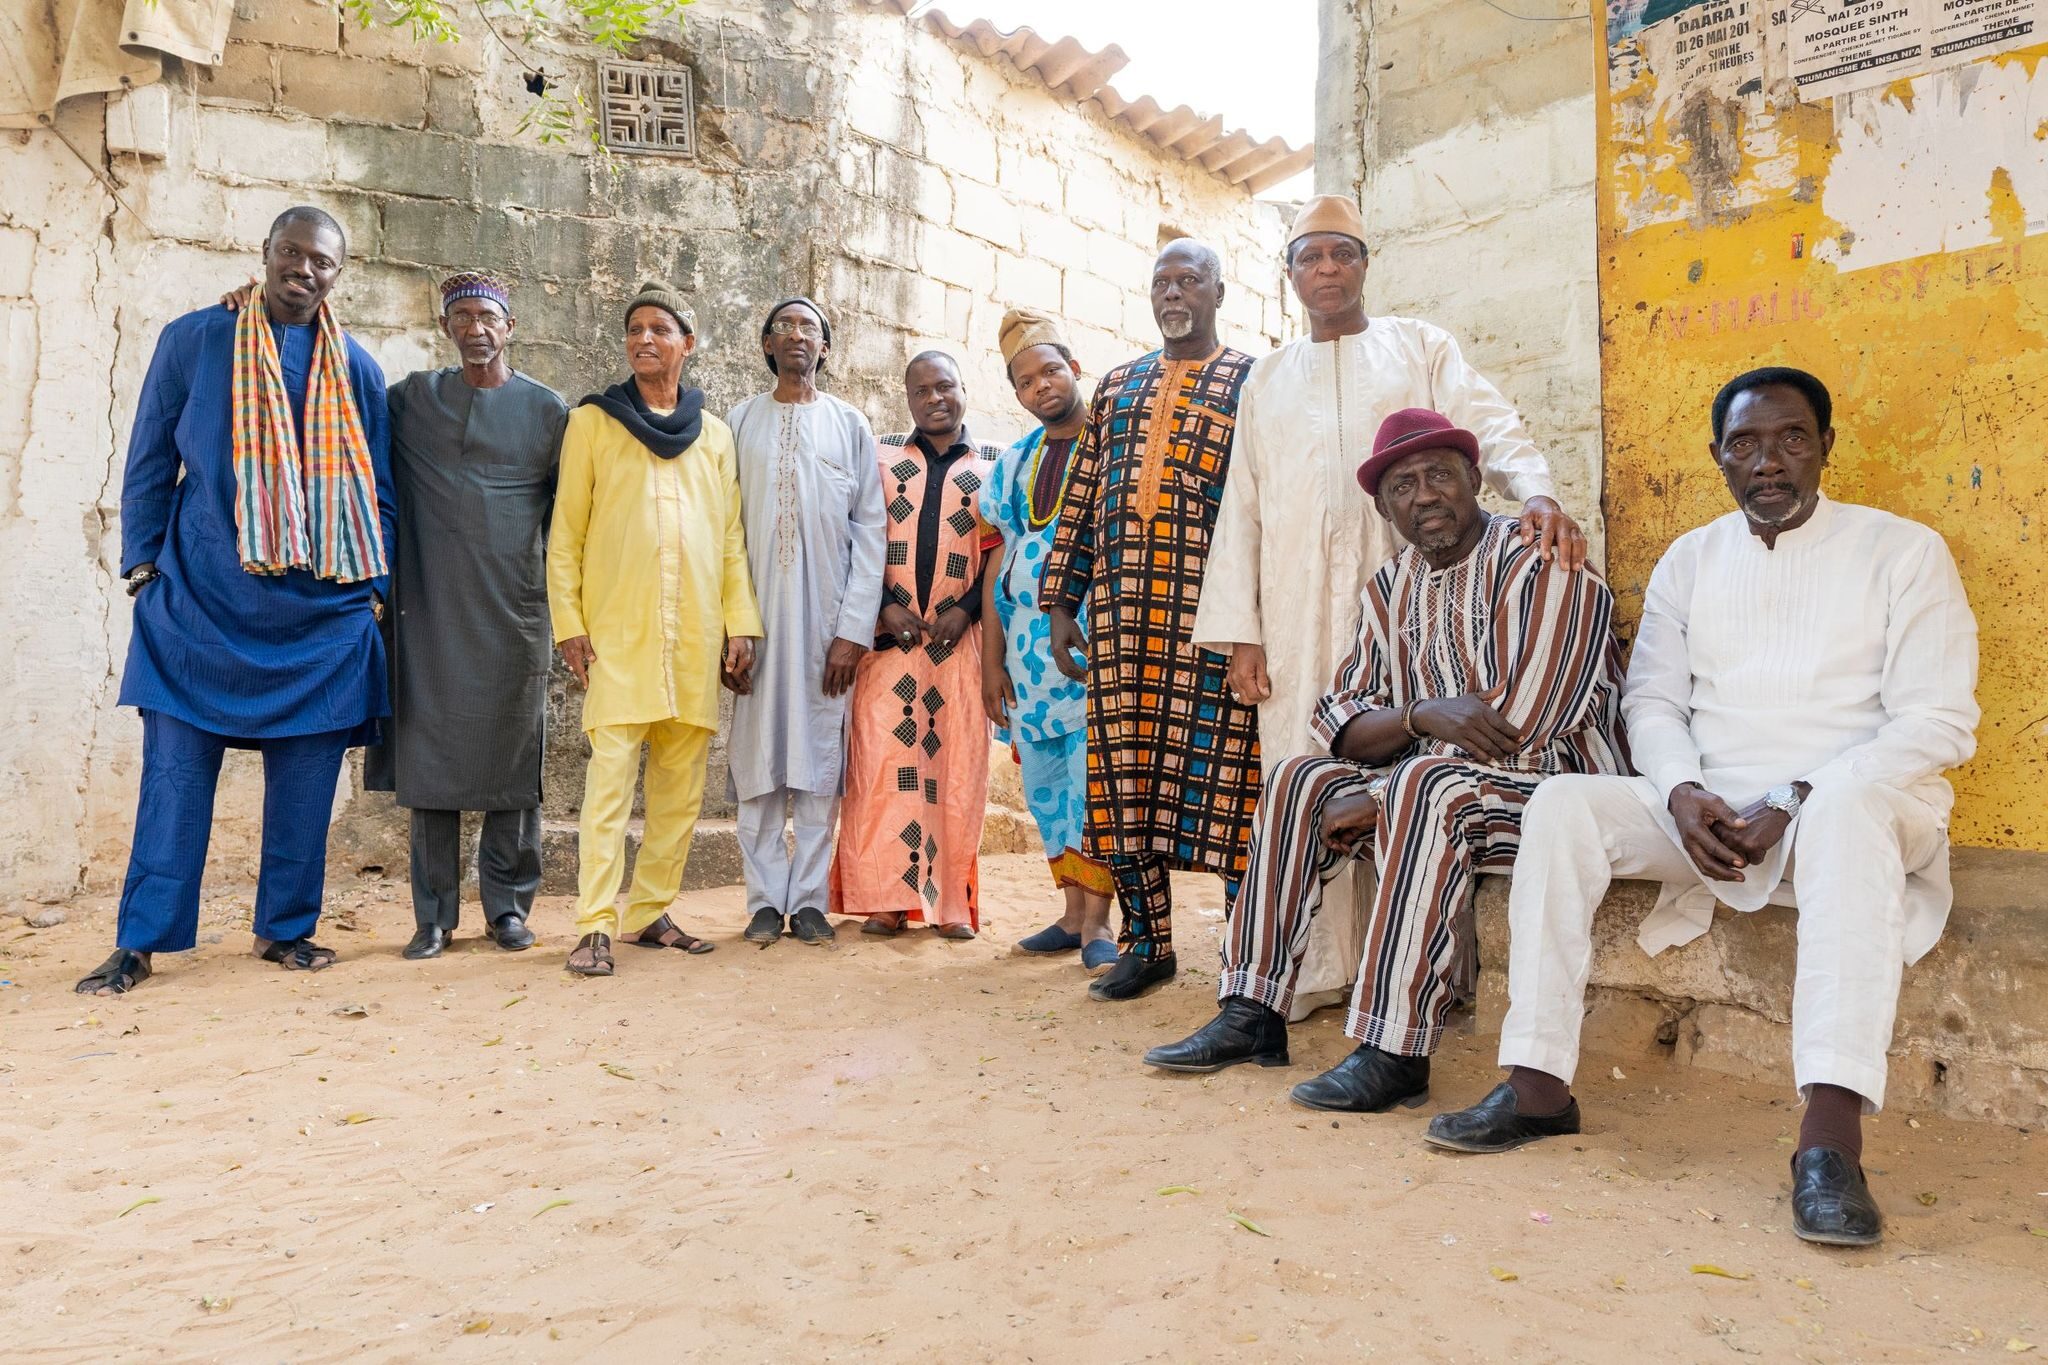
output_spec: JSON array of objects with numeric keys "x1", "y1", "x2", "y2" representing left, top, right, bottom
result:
[{"x1": 1501, "y1": 774, "x2": 1948, "y2": 1111}]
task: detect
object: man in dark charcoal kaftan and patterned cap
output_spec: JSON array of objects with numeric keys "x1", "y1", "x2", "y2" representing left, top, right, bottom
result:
[{"x1": 365, "y1": 272, "x2": 569, "y2": 958}]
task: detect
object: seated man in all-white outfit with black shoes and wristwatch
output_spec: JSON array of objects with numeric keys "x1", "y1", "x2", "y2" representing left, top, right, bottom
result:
[{"x1": 1427, "y1": 368, "x2": 1978, "y2": 1246}]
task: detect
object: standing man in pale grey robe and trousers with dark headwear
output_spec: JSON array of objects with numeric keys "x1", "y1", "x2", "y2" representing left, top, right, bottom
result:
[{"x1": 725, "y1": 299, "x2": 887, "y2": 943}]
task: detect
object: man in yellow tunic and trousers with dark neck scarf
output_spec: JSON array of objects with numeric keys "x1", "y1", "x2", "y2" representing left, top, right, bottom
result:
[{"x1": 547, "y1": 282, "x2": 762, "y2": 976}]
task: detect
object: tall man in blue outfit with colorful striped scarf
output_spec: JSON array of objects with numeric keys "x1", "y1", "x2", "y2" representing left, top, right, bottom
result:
[{"x1": 78, "y1": 207, "x2": 393, "y2": 995}]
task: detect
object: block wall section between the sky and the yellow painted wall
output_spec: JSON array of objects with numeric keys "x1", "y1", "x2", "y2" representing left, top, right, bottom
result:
[{"x1": 1319, "y1": 0, "x2": 1604, "y2": 551}]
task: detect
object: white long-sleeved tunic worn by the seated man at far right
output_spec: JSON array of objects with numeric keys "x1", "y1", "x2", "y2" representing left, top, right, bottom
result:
[{"x1": 1622, "y1": 497, "x2": 1978, "y2": 962}]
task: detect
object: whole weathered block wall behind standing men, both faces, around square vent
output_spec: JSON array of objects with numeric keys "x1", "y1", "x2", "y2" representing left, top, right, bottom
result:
[{"x1": 0, "y1": 0, "x2": 1284, "y2": 900}]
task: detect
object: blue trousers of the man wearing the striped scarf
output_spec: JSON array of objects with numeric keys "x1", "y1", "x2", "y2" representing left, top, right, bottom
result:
[{"x1": 115, "y1": 710, "x2": 350, "y2": 954}]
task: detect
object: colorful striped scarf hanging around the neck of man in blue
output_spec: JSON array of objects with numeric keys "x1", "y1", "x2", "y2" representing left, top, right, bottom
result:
[{"x1": 233, "y1": 291, "x2": 387, "y2": 583}]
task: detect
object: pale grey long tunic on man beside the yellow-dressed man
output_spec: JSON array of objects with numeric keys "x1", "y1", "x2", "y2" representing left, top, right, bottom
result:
[{"x1": 725, "y1": 393, "x2": 887, "y2": 800}]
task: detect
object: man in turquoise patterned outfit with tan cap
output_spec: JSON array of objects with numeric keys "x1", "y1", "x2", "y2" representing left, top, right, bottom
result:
[{"x1": 981, "y1": 309, "x2": 1116, "y2": 972}]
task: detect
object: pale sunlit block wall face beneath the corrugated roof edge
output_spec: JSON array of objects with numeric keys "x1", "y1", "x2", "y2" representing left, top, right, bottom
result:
[{"x1": 819, "y1": 10, "x2": 1294, "y2": 442}]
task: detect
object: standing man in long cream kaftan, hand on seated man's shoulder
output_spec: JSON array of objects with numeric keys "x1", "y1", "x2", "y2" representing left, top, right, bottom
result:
[{"x1": 1194, "y1": 194, "x2": 1585, "y2": 1019}]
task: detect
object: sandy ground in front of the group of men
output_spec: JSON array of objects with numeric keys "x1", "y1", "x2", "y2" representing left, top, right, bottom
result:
[{"x1": 0, "y1": 855, "x2": 2048, "y2": 1361}]
